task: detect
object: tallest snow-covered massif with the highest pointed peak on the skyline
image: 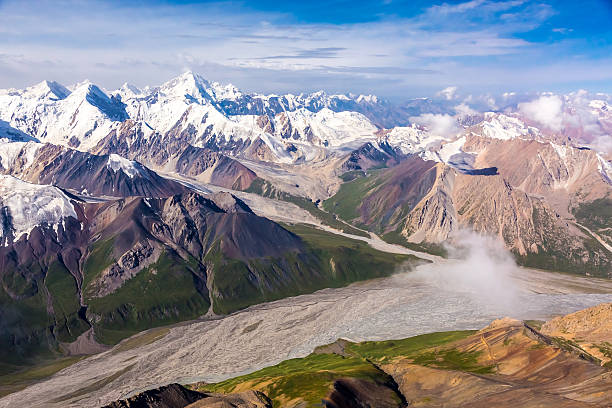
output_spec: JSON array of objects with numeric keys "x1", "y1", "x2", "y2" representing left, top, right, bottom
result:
[{"x1": 110, "y1": 72, "x2": 377, "y2": 162}]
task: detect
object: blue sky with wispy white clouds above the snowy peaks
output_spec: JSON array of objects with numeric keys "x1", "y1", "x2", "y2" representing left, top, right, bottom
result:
[{"x1": 0, "y1": 0, "x2": 612, "y2": 99}]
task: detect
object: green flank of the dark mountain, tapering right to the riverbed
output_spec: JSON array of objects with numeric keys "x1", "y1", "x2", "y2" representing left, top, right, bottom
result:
[{"x1": 209, "y1": 225, "x2": 417, "y2": 313}]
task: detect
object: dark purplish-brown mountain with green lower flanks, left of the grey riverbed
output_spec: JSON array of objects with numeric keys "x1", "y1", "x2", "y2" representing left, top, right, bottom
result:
[{"x1": 0, "y1": 189, "x2": 413, "y2": 364}]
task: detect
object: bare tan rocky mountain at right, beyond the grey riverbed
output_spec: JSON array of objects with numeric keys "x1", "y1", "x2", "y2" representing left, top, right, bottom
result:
[{"x1": 324, "y1": 147, "x2": 612, "y2": 276}]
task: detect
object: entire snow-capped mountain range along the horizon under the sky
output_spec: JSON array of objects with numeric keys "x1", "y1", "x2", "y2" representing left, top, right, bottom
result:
[{"x1": 0, "y1": 72, "x2": 612, "y2": 175}]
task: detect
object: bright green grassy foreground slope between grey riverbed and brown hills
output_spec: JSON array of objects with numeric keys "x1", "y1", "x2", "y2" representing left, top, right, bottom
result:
[{"x1": 194, "y1": 331, "x2": 480, "y2": 407}]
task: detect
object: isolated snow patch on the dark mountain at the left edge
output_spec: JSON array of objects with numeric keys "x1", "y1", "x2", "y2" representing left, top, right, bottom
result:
[{"x1": 0, "y1": 175, "x2": 78, "y2": 245}]
